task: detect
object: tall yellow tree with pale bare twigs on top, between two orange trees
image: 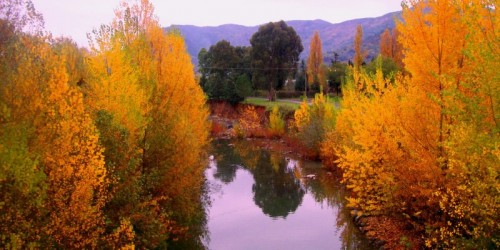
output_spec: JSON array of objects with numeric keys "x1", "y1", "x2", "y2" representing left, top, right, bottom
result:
[{"x1": 82, "y1": 6, "x2": 151, "y2": 246}]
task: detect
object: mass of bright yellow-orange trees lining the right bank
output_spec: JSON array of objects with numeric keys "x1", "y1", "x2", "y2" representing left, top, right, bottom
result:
[{"x1": 295, "y1": 0, "x2": 500, "y2": 249}]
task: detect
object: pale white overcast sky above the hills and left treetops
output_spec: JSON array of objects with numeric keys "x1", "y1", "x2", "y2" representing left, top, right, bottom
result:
[{"x1": 32, "y1": 0, "x2": 401, "y2": 46}]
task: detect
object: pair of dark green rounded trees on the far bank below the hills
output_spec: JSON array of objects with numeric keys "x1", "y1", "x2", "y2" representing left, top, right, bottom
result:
[{"x1": 198, "y1": 21, "x2": 303, "y2": 103}]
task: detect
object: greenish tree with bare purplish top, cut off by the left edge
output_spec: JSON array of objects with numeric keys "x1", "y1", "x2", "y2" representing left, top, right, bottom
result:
[{"x1": 0, "y1": 1, "x2": 47, "y2": 248}]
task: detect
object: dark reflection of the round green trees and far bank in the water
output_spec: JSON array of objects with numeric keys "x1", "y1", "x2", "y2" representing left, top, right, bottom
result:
[{"x1": 213, "y1": 141, "x2": 305, "y2": 218}]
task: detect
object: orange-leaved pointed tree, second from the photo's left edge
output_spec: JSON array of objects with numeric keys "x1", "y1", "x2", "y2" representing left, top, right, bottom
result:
[{"x1": 36, "y1": 61, "x2": 107, "y2": 248}]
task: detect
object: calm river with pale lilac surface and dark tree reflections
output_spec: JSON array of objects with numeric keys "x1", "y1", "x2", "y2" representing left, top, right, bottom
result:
[{"x1": 203, "y1": 140, "x2": 370, "y2": 250}]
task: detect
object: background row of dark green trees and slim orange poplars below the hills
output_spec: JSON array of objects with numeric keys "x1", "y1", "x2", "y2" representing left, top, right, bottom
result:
[{"x1": 198, "y1": 21, "x2": 402, "y2": 104}]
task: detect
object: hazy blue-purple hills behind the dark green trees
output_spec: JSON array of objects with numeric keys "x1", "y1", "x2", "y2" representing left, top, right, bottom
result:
[{"x1": 167, "y1": 12, "x2": 401, "y2": 66}]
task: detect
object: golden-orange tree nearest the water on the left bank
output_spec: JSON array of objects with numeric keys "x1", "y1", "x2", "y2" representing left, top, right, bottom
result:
[{"x1": 143, "y1": 26, "x2": 209, "y2": 246}]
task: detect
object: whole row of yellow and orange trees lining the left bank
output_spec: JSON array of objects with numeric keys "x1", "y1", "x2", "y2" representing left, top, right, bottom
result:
[{"x1": 0, "y1": 0, "x2": 208, "y2": 249}]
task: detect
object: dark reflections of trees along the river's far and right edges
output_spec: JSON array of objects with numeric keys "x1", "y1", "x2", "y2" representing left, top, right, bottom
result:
[{"x1": 205, "y1": 140, "x2": 370, "y2": 249}]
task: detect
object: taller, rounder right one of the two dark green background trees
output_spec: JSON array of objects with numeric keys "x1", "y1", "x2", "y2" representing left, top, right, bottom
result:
[{"x1": 250, "y1": 21, "x2": 304, "y2": 100}]
